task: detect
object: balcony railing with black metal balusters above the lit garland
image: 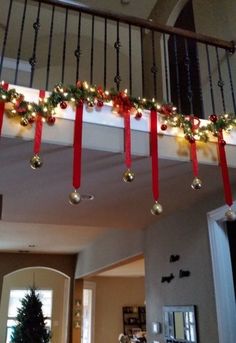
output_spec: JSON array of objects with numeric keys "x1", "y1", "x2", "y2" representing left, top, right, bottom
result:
[{"x1": 0, "y1": 0, "x2": 236, "y2": 117}]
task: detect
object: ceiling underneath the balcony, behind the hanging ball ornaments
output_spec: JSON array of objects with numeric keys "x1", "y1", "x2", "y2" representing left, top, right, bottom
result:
[{"x1": 0, "y1": 138, "x2": 233, "y2": 253}]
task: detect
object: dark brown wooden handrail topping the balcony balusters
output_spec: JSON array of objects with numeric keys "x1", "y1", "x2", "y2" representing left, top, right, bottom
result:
[{"x1": 33, "y1": 0, "x2": 235, "y2": 53}]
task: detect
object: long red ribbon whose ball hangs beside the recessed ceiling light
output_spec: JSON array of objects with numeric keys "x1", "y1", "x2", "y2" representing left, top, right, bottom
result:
[{"x1": 73, "y1": 102, "x2": 83, "y2": 189}]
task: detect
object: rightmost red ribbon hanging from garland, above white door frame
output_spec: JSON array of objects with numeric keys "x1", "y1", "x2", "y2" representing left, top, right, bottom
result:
[{"x1": 218, "y1": 130, "x2": 233, "y2": 206}]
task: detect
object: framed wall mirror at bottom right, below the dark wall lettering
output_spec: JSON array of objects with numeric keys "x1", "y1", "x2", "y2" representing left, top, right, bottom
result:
[{"x1": 163, "y1": 305, "x2": 197, "y2": 343}]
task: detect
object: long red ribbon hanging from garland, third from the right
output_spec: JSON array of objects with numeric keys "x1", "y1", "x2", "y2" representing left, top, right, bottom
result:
[{"x1": 150, "y1": 110, "x2": 159, "y2": 201}]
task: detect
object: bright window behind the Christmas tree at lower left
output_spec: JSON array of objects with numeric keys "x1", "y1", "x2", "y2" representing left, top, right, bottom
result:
[{"x1": 6, "y1": 289, "x2": 52, "y2": 343}]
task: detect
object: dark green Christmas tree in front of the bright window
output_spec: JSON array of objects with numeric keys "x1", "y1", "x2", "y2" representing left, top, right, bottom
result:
[{"x1": 11, "y1": 288, "x2": 51, "y2": 343}]
